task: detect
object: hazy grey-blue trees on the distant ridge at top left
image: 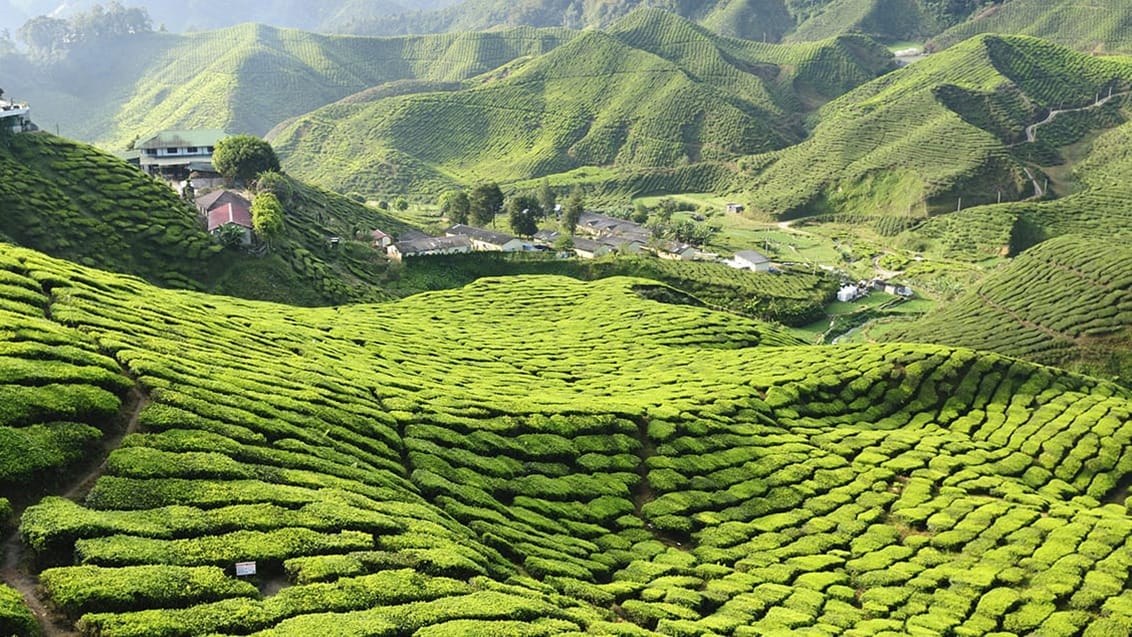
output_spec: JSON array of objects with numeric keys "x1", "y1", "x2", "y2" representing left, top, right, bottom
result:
[{"x1": 15, "y1": 0, "x2": 153, "y2": 58}]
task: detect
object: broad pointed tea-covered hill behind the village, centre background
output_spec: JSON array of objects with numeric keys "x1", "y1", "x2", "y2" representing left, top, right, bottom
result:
[{"x1": 273, "y1": 10, "x2": 891, "y2": 192}]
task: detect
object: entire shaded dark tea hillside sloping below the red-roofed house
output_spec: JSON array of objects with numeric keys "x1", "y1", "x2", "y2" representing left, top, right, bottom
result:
[{"x1": 0, "y1": 132, "x2": 418, "y2": 304}]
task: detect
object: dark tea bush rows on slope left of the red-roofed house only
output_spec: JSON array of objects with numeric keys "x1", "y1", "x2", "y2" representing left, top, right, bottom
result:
[{"x1": 0, "y1": 134, "x2": 220, "y2": 286}]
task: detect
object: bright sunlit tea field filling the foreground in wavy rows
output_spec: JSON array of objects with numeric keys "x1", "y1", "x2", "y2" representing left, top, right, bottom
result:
[{"x1": 0, "y1": 243, "x2": 1132, "y2": 637}]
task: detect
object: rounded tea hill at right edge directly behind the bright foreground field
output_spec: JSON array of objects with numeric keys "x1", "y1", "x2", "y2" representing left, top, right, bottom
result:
[{"x1": 890, "y1": 235, "x2": 1132, "y2": 384}]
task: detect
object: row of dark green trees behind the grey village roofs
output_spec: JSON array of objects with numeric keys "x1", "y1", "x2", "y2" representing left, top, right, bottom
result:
[{"x1": 439, "y1": 181, "x2": 584, "y2": 236}]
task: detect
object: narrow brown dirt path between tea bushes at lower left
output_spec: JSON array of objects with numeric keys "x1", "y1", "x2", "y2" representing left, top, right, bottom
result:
[{"x1": 0, "y1": 385, "x2": 149, "y2": 637}]
